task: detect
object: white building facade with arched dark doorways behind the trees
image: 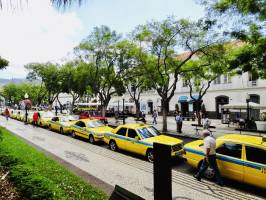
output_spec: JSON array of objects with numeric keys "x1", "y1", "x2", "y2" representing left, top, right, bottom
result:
[{"x1": 109, "y1": 72, "x2": 266, "y2": 119}]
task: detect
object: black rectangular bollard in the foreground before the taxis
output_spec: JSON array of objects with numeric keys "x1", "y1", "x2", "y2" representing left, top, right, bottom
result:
[{"x1": 153, "y1": 143, "x2": 172, "y2": 200}]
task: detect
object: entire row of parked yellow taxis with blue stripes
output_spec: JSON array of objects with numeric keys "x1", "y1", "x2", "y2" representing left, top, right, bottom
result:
[{"x1": 3, "y1": 111, "x2": 266, "y2": 189}]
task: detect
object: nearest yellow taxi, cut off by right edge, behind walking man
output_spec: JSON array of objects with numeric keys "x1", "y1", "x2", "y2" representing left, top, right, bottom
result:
[{"x1": 183, "y1": 134, "x2": 266, "y2": 189}]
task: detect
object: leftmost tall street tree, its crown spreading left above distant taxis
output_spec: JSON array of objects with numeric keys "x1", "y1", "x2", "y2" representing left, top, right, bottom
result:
[{"x1": 25, "y1": 63, "x2": 61, "y2": 106}]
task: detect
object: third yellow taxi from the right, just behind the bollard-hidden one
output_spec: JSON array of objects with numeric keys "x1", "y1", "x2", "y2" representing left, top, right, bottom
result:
[{"x1": 71, "y1": 119, "x2": 113, "y2": 144}]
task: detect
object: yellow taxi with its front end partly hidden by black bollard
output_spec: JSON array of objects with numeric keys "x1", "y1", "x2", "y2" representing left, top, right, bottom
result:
[{"x1": 105, "y1": 124, "x2": 183, "y2": 162}]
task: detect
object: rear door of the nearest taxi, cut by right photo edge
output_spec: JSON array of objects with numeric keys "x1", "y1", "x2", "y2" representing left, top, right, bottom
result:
[{"x1": 244, "y1": 145, "x2": 266, "y2": 188}]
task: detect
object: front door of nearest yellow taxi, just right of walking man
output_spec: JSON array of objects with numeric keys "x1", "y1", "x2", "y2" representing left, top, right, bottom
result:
[{"x1": 216, "y1": 142, "x2": 244, "y2": 182}]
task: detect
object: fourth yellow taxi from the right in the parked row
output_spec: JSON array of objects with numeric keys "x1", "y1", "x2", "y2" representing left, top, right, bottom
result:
[{"x1": 47, "y1": 115, "x2": 78, "y2": 134}]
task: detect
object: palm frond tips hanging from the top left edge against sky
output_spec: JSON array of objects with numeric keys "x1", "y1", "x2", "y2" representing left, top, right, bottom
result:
[{"x1": 0, "y1": 0, "x2": 83, "y2": 9}]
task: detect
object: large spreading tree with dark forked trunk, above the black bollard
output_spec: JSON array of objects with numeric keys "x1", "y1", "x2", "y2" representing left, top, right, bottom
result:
[{"x1": 135, "y1": 18, "x2": 214, "y2": 131}]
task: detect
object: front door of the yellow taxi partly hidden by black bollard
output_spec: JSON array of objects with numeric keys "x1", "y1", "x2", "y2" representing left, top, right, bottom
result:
[{"x1": 126, "y1": 128, "x2": 147, "y2": 155}]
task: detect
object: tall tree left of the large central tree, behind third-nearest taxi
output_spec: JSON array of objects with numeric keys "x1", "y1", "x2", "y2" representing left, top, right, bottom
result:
[{"x1": 76, "y1": 26, "x2": 125, "y2": 116}]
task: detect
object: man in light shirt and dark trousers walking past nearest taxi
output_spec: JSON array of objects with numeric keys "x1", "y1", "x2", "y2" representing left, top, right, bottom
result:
[{"x1": 194, "y1": 130, "x2": 223, "y2": 186}]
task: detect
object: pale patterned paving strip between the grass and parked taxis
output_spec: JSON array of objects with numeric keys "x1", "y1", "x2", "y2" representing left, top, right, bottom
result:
[{"x1": 0, "y1": 117, "x2": 265, "y2": 200}]
